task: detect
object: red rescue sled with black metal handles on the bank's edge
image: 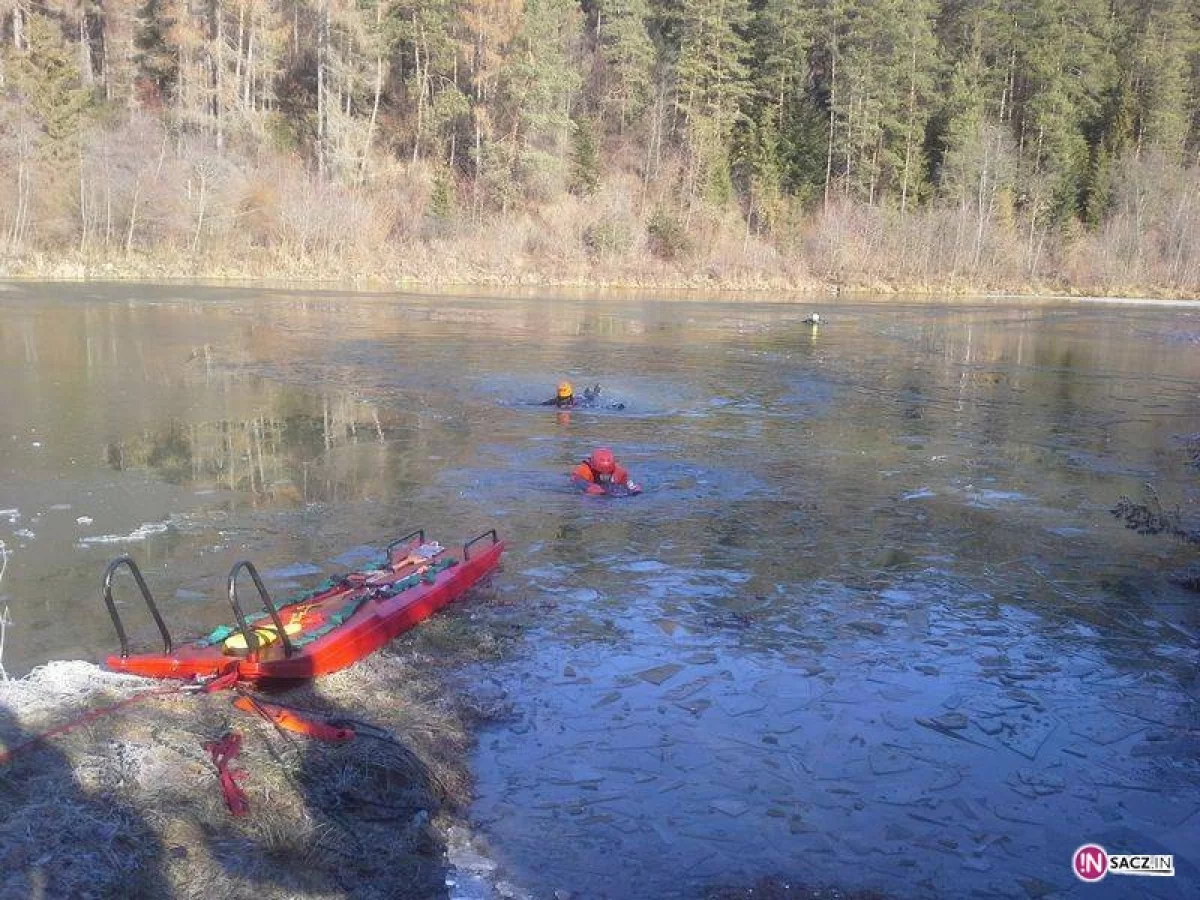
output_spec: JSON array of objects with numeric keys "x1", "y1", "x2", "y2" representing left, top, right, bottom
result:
[{"x1": 97, "y1": 528, "x2": 504, "y2": 682}]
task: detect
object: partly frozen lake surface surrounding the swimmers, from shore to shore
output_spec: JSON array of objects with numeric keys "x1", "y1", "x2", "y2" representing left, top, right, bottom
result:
[{"x1": 0, "y1": 286, "x2": 1200, "y2": 899}]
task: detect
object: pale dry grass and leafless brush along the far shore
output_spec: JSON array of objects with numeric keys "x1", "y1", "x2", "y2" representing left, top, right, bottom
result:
[{"x1": 0, "y1": 123, "x2": 1200, "y2": 296}]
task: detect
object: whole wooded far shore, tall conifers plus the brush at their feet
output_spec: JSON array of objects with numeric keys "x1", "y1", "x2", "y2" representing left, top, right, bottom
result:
[{"x1": 0, "y1": 0, "x2": 1200, "y2": 296}]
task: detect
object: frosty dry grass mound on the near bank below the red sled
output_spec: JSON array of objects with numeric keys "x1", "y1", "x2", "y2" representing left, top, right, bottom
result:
[{"x1": 0, "y1": 654, "x2": 469, "y2": 900}]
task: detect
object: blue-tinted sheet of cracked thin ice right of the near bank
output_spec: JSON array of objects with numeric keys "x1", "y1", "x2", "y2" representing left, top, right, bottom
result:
[{"x1": 476, "y1": 576, "x2": 1200, "y2": 898}]
